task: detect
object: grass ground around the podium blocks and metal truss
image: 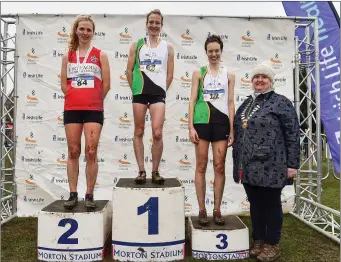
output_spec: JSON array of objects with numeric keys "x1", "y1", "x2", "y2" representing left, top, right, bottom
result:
[{"x1": 1, "y1": 159, "x2": 340, "y2": 262}]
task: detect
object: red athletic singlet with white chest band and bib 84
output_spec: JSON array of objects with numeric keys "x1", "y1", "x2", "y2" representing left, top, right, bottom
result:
[{"x1": 64, "y1": 47, "x2": 103, "y2": 111}]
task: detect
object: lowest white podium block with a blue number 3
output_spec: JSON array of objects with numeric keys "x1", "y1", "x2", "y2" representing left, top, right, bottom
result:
[{"x1": 188, "y1": 216, "x2": 249, "y2": 260}]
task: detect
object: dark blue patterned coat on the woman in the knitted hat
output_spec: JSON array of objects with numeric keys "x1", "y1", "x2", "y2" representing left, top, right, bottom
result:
[{"x1": 232, "y1": 91, "x2": 300, "y2": 188}]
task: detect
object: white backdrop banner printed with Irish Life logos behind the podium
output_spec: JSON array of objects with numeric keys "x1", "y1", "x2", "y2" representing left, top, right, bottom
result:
[{"x1": 15, "y1": 15, "x2": 295, "y2": 216}]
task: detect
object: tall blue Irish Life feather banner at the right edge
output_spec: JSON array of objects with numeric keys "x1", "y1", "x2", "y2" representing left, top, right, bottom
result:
[{"x1": 282, "y1": 1, "x2": 340, "y2": 173}]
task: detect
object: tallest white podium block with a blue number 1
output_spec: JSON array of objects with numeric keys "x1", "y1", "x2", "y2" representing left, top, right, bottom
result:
[{"x1": 112, "y1": 178, "x2": 185, "y2": 261}]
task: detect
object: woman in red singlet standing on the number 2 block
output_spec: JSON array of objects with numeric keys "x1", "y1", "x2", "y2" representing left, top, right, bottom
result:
[{"x1": 61, "y1": 15, "x2": 110, "y2": 210}]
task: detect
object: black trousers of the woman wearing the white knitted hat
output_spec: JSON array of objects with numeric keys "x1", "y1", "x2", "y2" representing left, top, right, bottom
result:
[{"x1": 243, "y1": 184, "x2": 283, "y2": 245}]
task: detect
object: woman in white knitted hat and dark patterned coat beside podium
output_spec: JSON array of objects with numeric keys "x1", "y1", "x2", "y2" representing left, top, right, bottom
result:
[{"x1": 233, "y1": 62, "x2": 300, "y2": 261}]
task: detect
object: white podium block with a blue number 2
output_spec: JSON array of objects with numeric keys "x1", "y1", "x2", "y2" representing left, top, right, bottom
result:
[{"x1": 37, "y1": 200, "x2": 112, "y2": 261}]
